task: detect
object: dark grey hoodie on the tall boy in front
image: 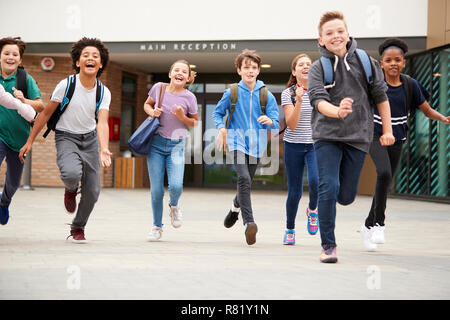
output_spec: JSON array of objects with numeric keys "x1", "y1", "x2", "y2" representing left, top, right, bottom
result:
[{"x1": 308, "y1": 38, "x2": 388, "y2": 153}]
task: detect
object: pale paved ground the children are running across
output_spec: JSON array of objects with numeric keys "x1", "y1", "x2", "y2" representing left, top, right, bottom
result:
[{"x1": 0, "y1": 188, "x2": 450, "y2": 300}]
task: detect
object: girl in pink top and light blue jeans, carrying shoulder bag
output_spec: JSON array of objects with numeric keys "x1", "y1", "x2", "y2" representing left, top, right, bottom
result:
[{"x1": 144, "y1": 60, "x2": 198, "y2": 241}]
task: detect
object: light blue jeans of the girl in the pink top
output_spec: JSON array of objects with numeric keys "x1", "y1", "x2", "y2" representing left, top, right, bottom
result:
[{"x1": 147, "y1": 134, "x2": 185, "y2": 227}]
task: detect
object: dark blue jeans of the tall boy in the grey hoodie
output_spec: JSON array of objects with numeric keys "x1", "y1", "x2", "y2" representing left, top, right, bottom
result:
[{"x1": 314, "y1": 140, "x2": 366, "y2": 249}]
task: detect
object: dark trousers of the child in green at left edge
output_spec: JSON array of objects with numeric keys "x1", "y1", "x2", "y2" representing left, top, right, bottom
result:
[{"x1": 0, "y1": 140, "x2": 23, "y2": 206}]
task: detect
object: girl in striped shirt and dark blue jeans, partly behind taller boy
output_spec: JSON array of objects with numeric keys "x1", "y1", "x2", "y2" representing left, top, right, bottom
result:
[{"x1": 281, "y1": 54, "x2": 319, "y2": 245}]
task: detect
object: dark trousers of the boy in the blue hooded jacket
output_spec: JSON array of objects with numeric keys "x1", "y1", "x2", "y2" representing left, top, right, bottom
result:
[{"x1": 233, "y1": 150, "x2": 259, "y2": 224}]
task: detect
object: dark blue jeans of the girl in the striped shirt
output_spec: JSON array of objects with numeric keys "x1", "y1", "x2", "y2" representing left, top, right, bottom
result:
[{"x1": 284, "y1": 141, "x2": 319, "y2": 229}]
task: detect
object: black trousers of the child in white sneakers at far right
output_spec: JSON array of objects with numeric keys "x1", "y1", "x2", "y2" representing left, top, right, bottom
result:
[{"x1": 365, "y1": 137, "x2": 403, "y2": 228}]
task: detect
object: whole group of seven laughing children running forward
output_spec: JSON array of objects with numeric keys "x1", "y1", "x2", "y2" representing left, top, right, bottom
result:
[{"x1": 0, "y1": 11, "x2": 450, "y2": 263}]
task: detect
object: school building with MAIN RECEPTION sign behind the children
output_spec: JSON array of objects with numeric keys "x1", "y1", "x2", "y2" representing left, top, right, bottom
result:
[{"x1": 0, "y1": 0, "x2": 450, "y2": 202}]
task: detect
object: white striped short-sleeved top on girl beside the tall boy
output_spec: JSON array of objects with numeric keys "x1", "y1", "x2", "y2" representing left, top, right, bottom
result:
[{"x1": 281, "y1": 88, "x2": 314, "y2": 143}]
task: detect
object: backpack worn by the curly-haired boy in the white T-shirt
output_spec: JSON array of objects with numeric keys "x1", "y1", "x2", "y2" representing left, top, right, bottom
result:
[{"x1": 44, "y1": 74, "x2": 105, "y2": 138}]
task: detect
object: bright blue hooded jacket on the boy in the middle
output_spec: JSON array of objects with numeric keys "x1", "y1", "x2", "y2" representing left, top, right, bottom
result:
[{"x1": 213, "y1": 80, "x2": 280, "y2": 158}]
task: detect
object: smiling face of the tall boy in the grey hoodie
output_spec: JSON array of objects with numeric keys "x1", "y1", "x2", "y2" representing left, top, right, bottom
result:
[{"x1": 319, "y1": 19, "x2": 350, "y2": 56}]
